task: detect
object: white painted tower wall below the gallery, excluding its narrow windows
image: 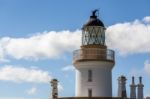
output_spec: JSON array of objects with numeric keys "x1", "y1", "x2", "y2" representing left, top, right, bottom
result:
[{"x1": 74, "y1": 61, "x2": 114, "y2": 97}]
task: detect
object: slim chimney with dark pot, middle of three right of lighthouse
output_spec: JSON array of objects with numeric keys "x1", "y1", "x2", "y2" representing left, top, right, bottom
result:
[{"x1": 130, "y1": 76, "x2": 136, "y2": 99}]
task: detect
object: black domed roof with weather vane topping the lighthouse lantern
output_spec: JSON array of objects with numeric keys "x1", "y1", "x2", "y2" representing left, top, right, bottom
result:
[{"x1": 83, "y1": 10, "x2": 105, "y2": 28}]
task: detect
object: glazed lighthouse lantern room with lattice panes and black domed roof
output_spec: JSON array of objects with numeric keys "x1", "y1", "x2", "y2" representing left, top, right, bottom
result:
[{"x1": 82, "y1": 10, "x2": 105, "y2": 46}]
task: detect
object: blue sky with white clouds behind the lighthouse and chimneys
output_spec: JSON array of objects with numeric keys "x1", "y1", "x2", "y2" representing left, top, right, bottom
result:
[{"x1": 0, "y1": 0, "x2": 150, "y2": 99}]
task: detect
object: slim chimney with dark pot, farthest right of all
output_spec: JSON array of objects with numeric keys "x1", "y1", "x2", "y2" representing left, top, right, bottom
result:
[{"x1": 137, "y1": 77, "x2": 144, "y2": 99}]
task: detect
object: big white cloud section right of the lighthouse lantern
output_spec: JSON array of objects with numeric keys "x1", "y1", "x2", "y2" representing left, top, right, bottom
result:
[{"x1": 106, "y1": 16, "x2": 150, "y2": 55}]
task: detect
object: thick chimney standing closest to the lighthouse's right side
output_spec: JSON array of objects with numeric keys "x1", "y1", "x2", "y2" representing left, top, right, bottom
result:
[{"x1": 118, "y1": 75, "x2": 127, "y2": 98}]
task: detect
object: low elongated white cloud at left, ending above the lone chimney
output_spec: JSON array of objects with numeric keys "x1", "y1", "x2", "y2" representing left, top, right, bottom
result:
[{"x1": 0, "y1": 66, "x2": 52, "y2": 83}]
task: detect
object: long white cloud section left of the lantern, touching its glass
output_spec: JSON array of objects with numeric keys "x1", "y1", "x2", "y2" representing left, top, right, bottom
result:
[{"x1": 0, "y1": 30, "x2": 81, "y2": 60}]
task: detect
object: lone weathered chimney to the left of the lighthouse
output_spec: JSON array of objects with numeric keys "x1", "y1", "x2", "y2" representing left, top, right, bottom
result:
[{"x1": 50, "y1": 79, "x2": 58, "y2": 99}]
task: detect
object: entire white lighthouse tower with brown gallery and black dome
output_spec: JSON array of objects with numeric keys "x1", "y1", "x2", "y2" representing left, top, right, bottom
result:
[{"x1": 73, "y1": 10, "x2": 115, "y2": 97}]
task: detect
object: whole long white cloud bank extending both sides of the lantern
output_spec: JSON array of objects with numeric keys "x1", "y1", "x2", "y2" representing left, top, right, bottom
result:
[{"x1": 0, "y1": 16, "x2": 150, "y2": 62}]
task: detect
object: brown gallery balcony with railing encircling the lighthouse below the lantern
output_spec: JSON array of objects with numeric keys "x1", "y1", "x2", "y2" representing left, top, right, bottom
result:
[{"x1": 73, "y1": 48, "x2": 115, "y2": 63}]
